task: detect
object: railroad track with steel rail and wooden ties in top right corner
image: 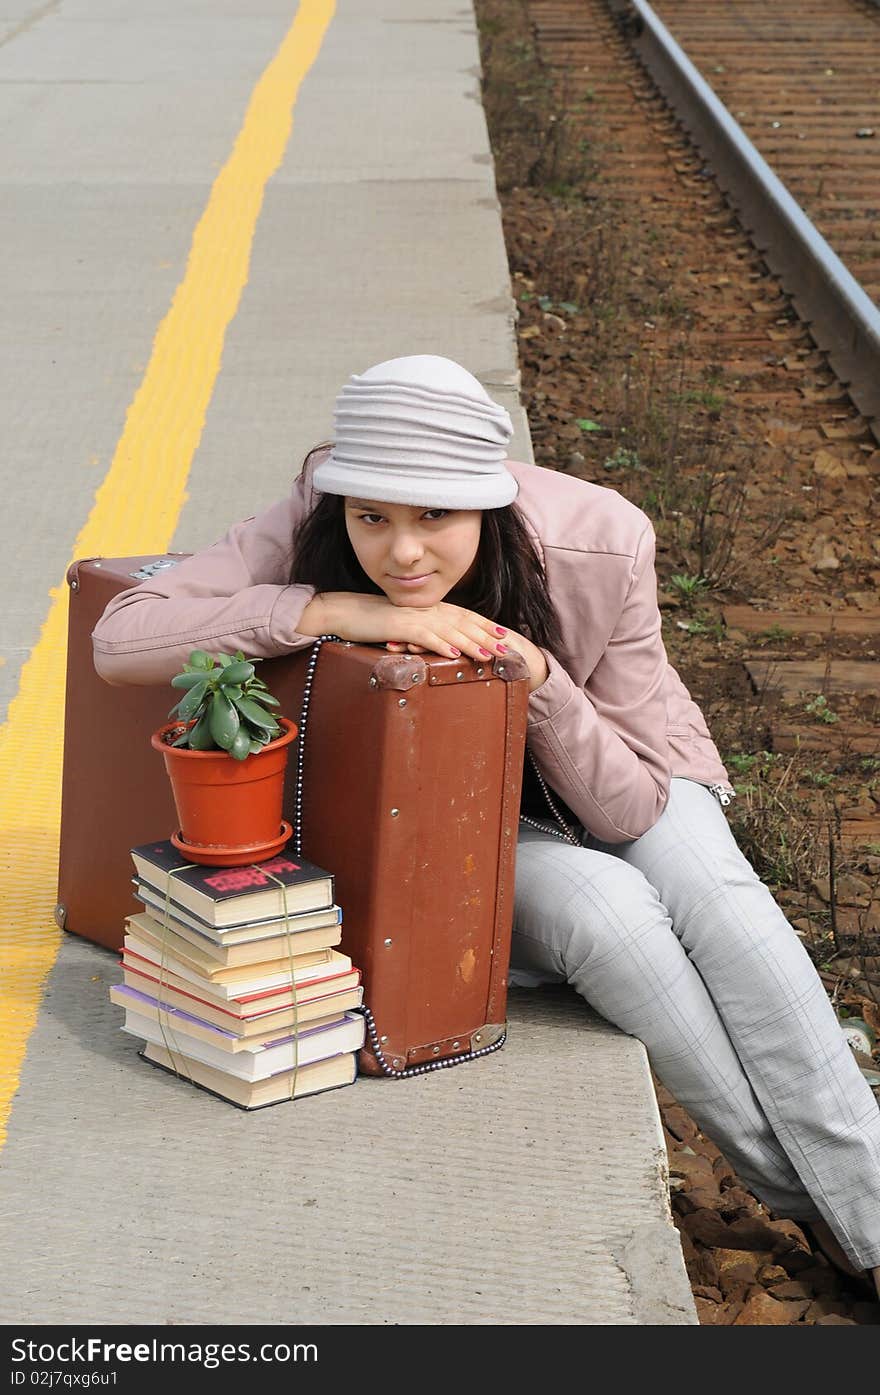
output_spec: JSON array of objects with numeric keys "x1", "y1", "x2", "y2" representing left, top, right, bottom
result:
[{"x1": 609, "y1": 0, "x2": 880, "y2": 441}]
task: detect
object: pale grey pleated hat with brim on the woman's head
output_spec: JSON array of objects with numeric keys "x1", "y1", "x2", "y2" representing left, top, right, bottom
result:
[{"x1": 314, "y1": 354, "x2": 519, "y2": 509}]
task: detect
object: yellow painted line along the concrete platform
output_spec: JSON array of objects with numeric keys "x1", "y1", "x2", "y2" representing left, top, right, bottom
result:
[{"x1": 0, "y1": 0, "x2": 336, "y2": 1144}]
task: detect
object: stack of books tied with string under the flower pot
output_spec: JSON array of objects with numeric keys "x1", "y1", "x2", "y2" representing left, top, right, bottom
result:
[{"x1": 110, "y1": 840, "x2": 364, "y2": 1109}]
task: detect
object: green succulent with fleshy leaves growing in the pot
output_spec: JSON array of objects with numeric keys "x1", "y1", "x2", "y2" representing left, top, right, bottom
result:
[{"x1": 169, "y1": 649, "x2": 282, "y2": 760}]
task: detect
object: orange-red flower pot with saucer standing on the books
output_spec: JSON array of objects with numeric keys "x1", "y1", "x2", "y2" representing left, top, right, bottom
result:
[{"x1": 151, "y1": 717, "x2": 297, "y2": 866}]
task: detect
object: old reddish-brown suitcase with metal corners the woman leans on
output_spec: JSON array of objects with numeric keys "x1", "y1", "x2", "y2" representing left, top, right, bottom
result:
[{"x1": 57, "y1": 554, "x2": 529, "y2": 1074}]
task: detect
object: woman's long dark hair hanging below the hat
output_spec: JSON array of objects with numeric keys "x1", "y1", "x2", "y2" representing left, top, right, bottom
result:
[{"x1": 290, "y1": 454, "x2": 562, "y2": 654}]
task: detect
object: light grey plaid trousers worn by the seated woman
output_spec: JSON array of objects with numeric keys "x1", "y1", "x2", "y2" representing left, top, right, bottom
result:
[{"x1": 510, "y1": 778, "x2": 880, "y2": 1268}]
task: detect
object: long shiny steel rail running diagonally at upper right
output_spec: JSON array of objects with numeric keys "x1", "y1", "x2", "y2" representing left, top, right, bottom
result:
[{"x1": 608, "y1": 0, "x2": 880, "y2": 441}]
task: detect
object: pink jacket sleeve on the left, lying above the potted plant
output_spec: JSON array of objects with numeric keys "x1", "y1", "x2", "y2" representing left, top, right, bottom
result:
[{"x1": 92, "y1": 476, "x2": 314, "y2": 684}]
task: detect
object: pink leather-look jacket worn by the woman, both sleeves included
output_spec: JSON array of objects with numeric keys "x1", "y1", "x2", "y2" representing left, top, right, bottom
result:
[{"x1": 92, "y1": 455, "x2": 729, "y2": 843}]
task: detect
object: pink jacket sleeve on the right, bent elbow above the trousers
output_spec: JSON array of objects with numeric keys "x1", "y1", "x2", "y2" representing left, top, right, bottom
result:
[{"x1": 529, "y1": 523, "x2": 669, "y2": 843}]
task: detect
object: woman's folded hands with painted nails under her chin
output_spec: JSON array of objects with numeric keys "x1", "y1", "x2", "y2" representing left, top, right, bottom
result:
[{"x1": 300, "y1": 591, "x2": 549, "y2": 692}]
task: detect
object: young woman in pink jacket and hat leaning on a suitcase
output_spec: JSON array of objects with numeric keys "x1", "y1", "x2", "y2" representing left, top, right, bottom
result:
[{"x1": 93, "y1": 354, "x2": 880, "y2": 1293}]
